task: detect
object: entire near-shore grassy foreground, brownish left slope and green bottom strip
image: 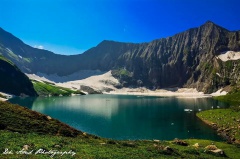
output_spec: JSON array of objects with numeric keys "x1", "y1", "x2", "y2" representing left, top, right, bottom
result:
[{"x1": 0, "y1": 102, "x2": 240, "y2": 159}]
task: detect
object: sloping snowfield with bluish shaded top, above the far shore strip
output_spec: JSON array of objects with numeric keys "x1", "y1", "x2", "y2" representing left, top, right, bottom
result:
[{"x1": 26, "y1": 70, "x2": 120, "y2": 92}]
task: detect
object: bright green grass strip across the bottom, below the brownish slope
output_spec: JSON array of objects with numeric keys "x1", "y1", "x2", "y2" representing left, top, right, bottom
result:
[{"x1": 0, "y1": 131, "x2": 240, "y2": 159}]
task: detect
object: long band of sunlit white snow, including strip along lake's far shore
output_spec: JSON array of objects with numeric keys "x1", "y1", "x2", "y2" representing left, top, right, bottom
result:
[{"x1": 28, "y1": 70, "x2": 227, "y2": 98}]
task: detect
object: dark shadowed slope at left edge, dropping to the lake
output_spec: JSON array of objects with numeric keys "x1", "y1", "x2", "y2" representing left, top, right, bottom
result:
[{"x1": 0, "y1": 56, "x2": 37, "y2": 96}]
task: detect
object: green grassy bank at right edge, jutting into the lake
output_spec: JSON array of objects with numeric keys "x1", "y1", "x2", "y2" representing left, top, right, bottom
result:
[{"x1": 197, "y1": 90, "x2": 240, "y2": 145}]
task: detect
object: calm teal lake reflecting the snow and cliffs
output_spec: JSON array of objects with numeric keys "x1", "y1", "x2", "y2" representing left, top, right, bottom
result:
[{"x1": 10, "y1": 95, "x2": 228, "y2": 140}]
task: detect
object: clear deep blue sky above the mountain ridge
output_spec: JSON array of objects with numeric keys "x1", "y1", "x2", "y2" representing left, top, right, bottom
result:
[{"x1": 0, "y1": 0, "x2": 240, "y2": 55}]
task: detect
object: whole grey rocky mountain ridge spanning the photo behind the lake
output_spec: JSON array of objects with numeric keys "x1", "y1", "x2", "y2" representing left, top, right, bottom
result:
[{"x1": 0, "y1": 21, "x2": 240, "y2": 92}]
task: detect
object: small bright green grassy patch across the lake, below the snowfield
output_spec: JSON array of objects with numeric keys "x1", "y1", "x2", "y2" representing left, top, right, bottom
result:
[{"x1": 32, "y1": 80, "x2": 84, "y2": 96}]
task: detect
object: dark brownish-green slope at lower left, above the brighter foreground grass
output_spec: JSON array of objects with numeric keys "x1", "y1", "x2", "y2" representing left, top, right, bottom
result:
[{"x1": 0, "y1": 101, "x2": 81, "y2": 136}]
